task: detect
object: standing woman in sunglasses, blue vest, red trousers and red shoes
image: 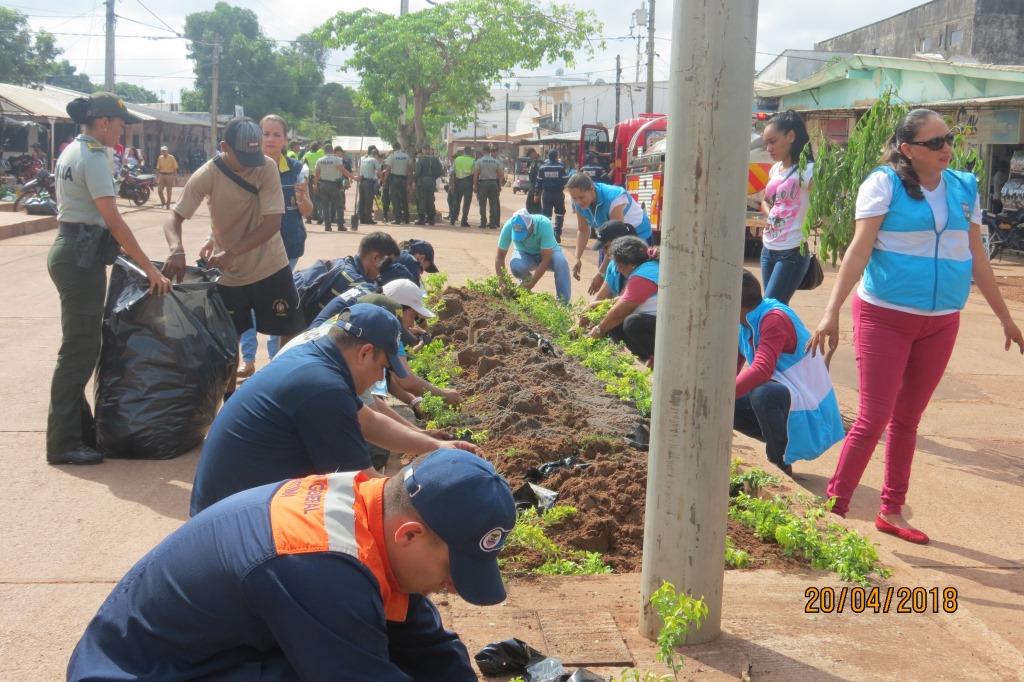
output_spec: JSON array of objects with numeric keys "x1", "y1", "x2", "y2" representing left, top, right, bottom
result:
[{"x1": 808, "y1": 109, "x2": 1024, "y2": 544}]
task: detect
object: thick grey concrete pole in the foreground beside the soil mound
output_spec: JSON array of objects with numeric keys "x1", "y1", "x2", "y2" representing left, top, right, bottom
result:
[{"x1": 640, "y1": 0, "x2": 758, "y2": 643}]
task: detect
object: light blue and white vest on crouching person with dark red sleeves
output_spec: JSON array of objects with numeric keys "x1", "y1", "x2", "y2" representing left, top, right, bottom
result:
[{"x1": 739, "y1": 298, "x2": 846, "y2": 464}]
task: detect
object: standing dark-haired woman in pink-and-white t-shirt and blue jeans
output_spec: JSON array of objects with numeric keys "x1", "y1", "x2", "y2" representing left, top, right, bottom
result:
[{"x1": 761, "y1": 110, "x2": 814, "y2": 304}]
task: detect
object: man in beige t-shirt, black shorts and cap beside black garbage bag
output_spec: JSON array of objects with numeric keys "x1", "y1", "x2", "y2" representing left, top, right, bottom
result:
[{"x1": 164, "y1": 118, "x2": 305, "y2": 391}]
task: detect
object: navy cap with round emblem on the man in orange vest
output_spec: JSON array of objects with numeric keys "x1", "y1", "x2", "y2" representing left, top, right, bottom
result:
[{"x1": 403, "y1": 450, "x2": 515, "y2": 606}]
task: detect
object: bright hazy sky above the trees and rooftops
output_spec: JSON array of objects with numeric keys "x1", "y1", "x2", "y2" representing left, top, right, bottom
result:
[{"x1": 14, "y1": 0, "x2": 923, "y2": 106}]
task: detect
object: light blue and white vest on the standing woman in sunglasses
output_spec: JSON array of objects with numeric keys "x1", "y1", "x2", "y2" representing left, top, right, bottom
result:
[{"x1": 864, "y1": 166, "x2": 978, "y2": 310}]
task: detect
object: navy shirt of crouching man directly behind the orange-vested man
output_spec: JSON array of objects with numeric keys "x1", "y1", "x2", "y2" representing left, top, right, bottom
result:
[{"x1": 188, "y1": 337, "x2": 370, "y2": 515}]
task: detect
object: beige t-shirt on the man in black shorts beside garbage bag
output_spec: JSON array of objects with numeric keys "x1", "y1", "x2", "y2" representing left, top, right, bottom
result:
[{"x1": 174, "y1": 157, "x2": 288, "y2": 287}]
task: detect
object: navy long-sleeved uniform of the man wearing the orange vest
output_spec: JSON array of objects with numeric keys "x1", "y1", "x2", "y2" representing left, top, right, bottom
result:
[{"x1": 68, "y1": 477, "x2": 476, "y2": 682}]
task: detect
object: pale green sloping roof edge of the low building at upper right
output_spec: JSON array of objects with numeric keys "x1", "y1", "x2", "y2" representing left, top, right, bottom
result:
[{"x1": 757, "y1": 54, "x2": 1024, "y2": 97}]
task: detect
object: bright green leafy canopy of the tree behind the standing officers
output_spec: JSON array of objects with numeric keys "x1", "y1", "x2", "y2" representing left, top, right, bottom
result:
[{"x1": 313, "y1": 0, "x2": 602, "y2": 145}]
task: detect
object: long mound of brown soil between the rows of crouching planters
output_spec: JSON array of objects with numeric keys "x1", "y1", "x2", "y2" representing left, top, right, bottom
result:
[{"x1": 432, "y1": 289, "x2": 806, "y2": 572}]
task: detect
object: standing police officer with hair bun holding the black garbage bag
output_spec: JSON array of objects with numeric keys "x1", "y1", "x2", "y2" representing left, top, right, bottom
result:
[{"x1": 46, "y1": 92, "x2": 171, "y2": 464}]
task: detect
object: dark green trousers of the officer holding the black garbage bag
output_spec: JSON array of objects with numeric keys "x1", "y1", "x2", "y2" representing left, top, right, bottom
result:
[{"x1": 46, "y1": 229, "x2": 106, "y2": 457}]
